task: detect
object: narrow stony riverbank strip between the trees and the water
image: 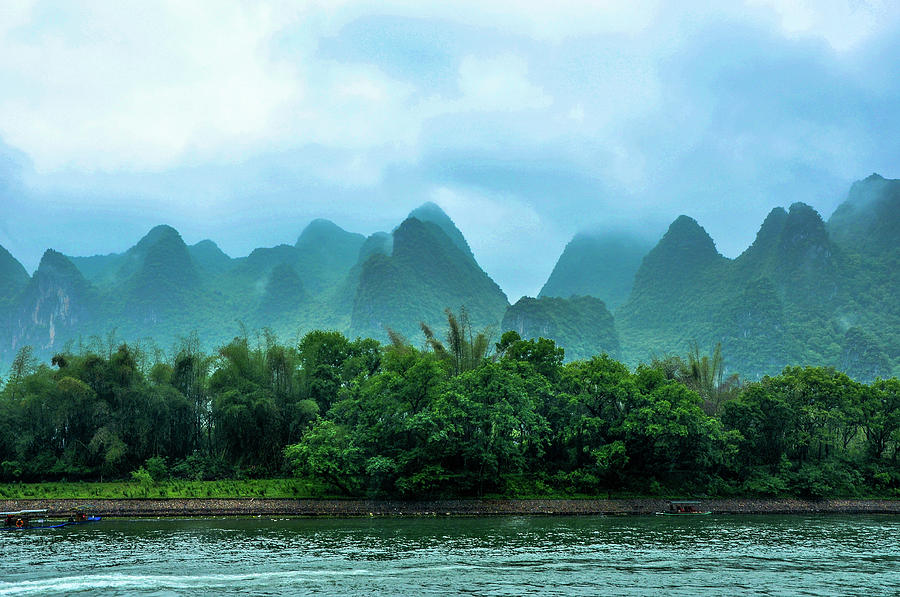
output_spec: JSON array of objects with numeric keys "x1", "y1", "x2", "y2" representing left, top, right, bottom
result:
[{"x1": 0, "y1": 498, "x2": 900, "y2": 518}]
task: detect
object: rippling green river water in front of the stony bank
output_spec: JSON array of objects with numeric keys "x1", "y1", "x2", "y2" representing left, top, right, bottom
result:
[{"x1": 0, "y1": 516, "x2": 900, "y2": 596}]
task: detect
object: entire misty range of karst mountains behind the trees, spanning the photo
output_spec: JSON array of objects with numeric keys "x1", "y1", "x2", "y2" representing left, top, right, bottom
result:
[{"x1": 0, "y1": 174, "x2": 900, "y2": 380}]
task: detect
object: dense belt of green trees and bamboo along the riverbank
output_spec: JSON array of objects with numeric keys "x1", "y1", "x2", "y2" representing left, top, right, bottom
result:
[{"x1": 0, "y1": 311, "x2": 900, "y2": 498}]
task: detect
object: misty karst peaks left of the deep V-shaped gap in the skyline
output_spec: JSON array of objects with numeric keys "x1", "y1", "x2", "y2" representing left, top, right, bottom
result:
[{"x1": 0, "y1": 203, "x2": 508, "y2": 371}]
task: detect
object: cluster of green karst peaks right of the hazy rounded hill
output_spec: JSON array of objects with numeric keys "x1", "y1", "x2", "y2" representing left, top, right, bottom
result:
[{"x1": 615, "y1": 175, "x2": 900, "y2": 380}]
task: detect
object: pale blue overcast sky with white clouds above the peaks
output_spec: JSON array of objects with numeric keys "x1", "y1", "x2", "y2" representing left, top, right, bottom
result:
[{"x1": 0, "y1": 0, "x2": 900, "y2": 301}]
